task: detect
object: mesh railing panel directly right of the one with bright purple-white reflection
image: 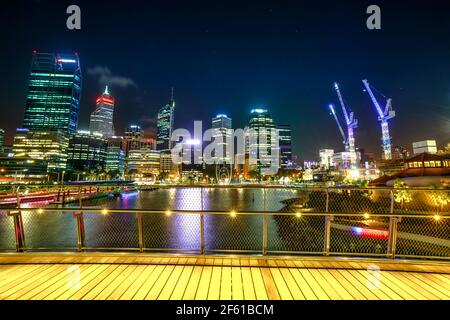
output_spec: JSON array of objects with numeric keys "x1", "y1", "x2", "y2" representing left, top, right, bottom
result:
[{"x1": 205, "y1": 214, "x2": 263, "y2": 251}]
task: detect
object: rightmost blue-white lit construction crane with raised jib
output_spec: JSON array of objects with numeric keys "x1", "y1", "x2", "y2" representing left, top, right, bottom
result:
[{"x1": 362, "y1": 80, "x2": 395, "y2": 160}]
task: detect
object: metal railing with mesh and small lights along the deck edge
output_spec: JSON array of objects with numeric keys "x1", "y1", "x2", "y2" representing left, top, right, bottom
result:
[{"x1": 0, "y1": 186, "x2": 450, "y2": 260}]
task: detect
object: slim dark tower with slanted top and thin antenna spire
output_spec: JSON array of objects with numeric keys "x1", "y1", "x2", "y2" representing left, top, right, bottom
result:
[{"x1": 156, "y1": 88, "x2": 175, "y2": 151}]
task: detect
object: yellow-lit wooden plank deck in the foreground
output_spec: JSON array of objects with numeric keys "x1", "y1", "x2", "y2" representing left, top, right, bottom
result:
[{"x1": 0, "y1": 254, "x2": 450, "y2": 300}]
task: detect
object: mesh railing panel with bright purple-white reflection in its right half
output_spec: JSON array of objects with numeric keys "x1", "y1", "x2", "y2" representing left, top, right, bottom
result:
[{"x1": 142, "y1": 214, "x2": 200, "y2": 251}]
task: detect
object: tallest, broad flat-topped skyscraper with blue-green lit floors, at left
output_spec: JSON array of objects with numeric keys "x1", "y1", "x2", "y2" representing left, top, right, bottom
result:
[{"x1": 23, "y1": 53, "x2": 81, "y2": 133}]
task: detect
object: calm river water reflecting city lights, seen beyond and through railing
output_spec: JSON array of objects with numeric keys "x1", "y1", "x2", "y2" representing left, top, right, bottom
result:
[{"x1": 0, "y1": 188, "x2": 446, "y2": 253}]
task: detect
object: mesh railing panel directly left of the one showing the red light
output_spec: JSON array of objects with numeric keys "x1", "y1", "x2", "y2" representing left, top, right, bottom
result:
[{"x1": 267, "y1": 214, "x2": 325, "y2": 253}]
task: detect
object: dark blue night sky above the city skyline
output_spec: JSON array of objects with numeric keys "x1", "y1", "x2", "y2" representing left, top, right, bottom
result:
[{"x1": 0, "y1": 0, "x2": 450, "y2": 159}]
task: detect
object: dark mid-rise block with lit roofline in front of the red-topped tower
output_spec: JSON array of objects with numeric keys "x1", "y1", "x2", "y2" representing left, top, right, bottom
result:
[{"x1": 67, "y1": 131, "x2": 107, "y2": 171}]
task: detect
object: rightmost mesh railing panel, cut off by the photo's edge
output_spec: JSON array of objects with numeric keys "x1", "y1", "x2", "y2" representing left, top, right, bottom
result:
[{"x1": 396, "y1": 217, "x2": 450, "y2": 258}]
